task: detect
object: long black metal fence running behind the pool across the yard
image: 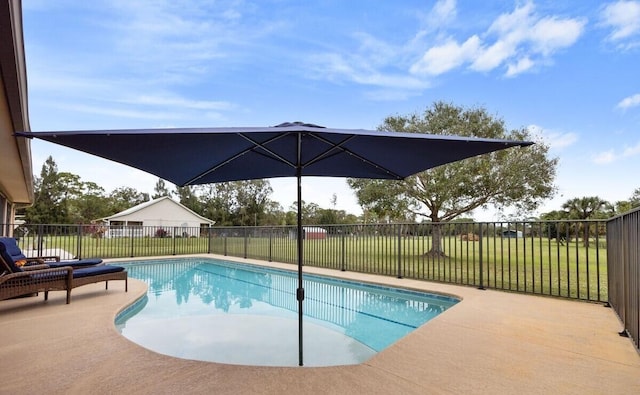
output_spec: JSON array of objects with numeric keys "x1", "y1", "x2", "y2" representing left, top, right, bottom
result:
[{"x1": 2, "y1": 220, "x2": 608, "y2": 302}]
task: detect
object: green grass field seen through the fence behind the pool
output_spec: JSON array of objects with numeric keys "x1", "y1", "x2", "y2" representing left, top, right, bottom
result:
[{"x1": 20, "y1": 234, "x2": 607, "y2": 302}]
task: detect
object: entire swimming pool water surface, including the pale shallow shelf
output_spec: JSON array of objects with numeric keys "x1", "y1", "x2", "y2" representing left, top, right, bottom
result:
[{"x1": 116, "y1": 259, "x2": 458, "y2": 366}]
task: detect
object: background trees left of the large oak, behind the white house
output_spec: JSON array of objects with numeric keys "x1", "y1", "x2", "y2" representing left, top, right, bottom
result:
[{"x1": 20, "y1": 156, "x2": 358, "y2": 226}]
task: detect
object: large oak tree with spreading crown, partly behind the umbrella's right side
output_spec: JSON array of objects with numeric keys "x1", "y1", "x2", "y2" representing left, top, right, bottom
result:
[{"x1": 348, "y1": 102, "x2": 558, "y2": 255}]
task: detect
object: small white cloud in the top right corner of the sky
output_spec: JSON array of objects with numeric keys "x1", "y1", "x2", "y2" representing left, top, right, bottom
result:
[{"x1": 601, "y1": 1, "x2": 640, "y2": 42}]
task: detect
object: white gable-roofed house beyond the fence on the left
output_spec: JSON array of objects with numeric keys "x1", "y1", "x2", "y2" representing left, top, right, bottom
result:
[{"x1": 102, "y1": 196, "x2": 215, "y2": 238}]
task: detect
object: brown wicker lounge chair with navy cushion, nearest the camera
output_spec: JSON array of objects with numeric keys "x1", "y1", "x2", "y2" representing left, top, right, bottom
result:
[{"x1": 0, "y1": 243, "x2": 129, "y2": 303}]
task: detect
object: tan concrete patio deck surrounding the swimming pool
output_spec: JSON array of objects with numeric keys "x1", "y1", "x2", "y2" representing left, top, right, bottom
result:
[{"x1": 0, "y1": 255, "x2": 640, "y2": 394}]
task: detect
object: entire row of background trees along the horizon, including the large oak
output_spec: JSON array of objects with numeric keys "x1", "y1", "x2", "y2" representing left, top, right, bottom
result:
[{"x1": 20, "y1": 102, "x2": 640, "y2": 226}]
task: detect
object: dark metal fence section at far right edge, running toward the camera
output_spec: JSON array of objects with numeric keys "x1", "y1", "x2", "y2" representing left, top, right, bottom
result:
[{"x1": 607, "y1": 209, "x2": 640, "y2": 351}]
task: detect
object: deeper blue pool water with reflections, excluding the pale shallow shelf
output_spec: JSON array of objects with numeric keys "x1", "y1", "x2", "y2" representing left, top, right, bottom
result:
[{"x1": 122, "y1": 260, "x2": 457, "y2": 351}]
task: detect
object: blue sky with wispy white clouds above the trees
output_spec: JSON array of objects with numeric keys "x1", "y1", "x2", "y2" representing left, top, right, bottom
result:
[{"x1": 23, "y1": 0, "x2": 640, "y2": 220}]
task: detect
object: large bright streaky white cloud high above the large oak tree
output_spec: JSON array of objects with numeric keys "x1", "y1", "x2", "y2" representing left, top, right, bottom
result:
[{"x1": 410, "y1": 2, "x2": 586, "y2": 77}]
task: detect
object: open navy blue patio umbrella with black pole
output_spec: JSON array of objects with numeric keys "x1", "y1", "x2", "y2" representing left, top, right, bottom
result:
[{"x1": 16, "y1": 122, "x2": 533, "y2": 366}]
